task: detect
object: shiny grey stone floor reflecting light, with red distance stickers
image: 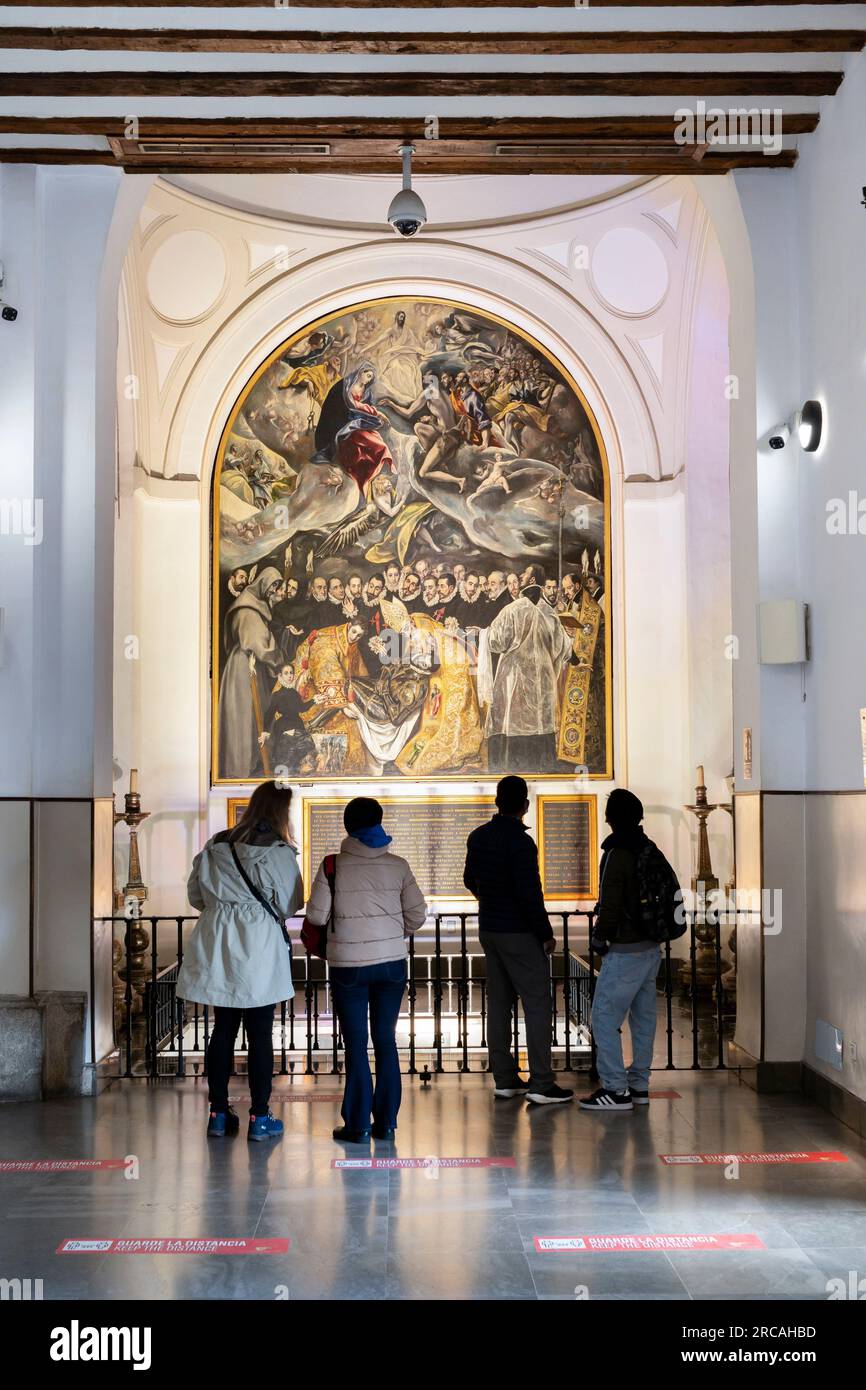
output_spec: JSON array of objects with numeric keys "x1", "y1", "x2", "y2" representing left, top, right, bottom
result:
[{"x1": 0, "y1": 1072, "x2": 866, "y2": 1301}]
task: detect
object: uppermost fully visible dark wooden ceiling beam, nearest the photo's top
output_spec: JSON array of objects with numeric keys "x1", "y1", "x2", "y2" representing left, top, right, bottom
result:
[{"x1": 0, "y1": 26, "x2": 866, "y2": 57}]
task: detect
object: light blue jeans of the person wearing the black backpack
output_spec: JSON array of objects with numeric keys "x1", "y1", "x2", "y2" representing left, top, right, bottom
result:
[{"x1": 592, "y1": 945, "x2": 659, "y2": 1091}]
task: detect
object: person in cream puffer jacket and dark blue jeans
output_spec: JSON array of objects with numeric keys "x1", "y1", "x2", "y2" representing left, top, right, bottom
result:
[{"x1": 304, "y1": 796, "x2": 427, "y2": 1144}]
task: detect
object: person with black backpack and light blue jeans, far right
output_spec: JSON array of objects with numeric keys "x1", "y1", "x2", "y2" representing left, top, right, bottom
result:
[{"x1": 580, "y1": 787, "x2": 681, "y2": 1115}]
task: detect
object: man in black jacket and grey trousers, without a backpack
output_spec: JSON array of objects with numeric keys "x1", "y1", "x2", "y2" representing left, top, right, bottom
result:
[{"x1": 463, "y1": 777, "x2": 574, "y2": 1105}]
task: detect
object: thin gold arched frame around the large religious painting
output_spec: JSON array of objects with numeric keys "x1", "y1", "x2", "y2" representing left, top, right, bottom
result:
[{"x1": 210, "y1": 291, "x2": 613, "y2": 787}]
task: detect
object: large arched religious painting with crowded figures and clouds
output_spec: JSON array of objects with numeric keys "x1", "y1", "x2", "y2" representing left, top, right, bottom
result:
[{"x1": 213, "y1": 296, "x2": 612, "y2": 783}]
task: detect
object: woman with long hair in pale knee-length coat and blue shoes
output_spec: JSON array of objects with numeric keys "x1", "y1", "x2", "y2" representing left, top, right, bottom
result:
[{"x1": 178, "y1": 781, "x2": 304, "y2": 1140}]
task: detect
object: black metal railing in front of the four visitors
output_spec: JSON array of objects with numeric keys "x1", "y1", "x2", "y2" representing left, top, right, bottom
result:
[{"x1": 97, "y1": 910, "x2": 734, "y2": 1080}]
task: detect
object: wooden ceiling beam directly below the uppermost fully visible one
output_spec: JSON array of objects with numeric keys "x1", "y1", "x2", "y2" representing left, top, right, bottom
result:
[{"x1": 0, "y1": 70, "x2": 842, "y2": 100}]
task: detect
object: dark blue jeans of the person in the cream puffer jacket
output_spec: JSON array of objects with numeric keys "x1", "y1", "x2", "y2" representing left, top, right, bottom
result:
[{"x1": 331, "y1": 960, "x2": 406, "y2": 1130}]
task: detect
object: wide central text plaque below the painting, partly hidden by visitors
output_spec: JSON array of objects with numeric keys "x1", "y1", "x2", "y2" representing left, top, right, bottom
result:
[{"x1": 303, "y1": 796, "x2": 493, "y2": 902}]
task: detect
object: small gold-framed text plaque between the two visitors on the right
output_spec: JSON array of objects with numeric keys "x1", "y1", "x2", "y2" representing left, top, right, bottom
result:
[{"x1": 538, "y1": 795, "x2": 598, "y2": 902}]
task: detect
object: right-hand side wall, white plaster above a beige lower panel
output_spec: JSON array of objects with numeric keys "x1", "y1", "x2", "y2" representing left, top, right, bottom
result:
[{"x1": 737, "y1": 56, "x2": 866, "y2": 1097}]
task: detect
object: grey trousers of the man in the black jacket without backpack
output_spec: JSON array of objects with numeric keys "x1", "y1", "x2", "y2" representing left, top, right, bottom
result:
[{"x1": 480, "y1": 931, "x2": 555, "y2": 1091}]
